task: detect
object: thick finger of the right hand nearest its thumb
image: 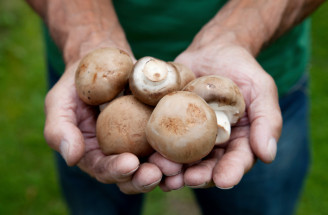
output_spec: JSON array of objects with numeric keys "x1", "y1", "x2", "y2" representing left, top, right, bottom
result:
[{"x1": 213, "y1": 137, "x2": 255, "y2": 189}]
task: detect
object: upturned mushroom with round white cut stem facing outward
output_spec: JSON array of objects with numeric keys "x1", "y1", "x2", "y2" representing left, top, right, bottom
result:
[{"x1": 129, "y1": 57, "x2": 180, "y2": 106}]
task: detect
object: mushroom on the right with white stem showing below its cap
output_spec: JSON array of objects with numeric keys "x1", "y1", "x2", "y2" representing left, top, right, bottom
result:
[{"x1": 183, "y1": 75, "x2": 245, "y2": 145}]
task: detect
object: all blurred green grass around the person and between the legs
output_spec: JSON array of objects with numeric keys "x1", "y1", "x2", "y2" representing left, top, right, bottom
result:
[{"x1": 0, "y1": 0, "x2": 328, "y2": 215}]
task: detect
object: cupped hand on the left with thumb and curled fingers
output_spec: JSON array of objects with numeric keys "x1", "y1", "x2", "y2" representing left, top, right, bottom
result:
[{"x1": 44, "y1": 53, "x2": 181, "y2": 194}]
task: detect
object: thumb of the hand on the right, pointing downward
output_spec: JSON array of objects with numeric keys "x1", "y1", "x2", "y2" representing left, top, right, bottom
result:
[{"x1": 247, "y1": 74, "x2": 282, "y2": 163}]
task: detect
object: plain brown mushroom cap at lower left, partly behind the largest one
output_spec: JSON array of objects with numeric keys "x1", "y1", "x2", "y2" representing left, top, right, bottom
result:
[{"x1": 96, "y1": 95, "x2": 153, "y2": 157}]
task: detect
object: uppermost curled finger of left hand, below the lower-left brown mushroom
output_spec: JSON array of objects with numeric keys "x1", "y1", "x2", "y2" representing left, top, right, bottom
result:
[{"x1": 78, "y1": 150, "x2": 140, "y2": 184}]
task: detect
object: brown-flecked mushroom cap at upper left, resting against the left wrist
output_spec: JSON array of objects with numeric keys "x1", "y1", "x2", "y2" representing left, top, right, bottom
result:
[{"x1": 75, "y1": 48, "x2": 133, "y2": 105}]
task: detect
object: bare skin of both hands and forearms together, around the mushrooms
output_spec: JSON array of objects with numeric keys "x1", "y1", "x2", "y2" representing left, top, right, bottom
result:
[{"x1": 28, "y1": 0, "x2": 325, "y2": 193}]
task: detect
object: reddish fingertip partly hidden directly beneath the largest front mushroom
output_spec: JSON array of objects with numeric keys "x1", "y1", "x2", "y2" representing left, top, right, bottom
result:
[{"x1": 149, "y1": 152, "x2": 182, "y2": 176}]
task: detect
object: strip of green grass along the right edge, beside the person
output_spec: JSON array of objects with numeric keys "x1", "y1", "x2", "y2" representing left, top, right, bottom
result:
[{"x1": 298, "y1": 3, "x2": 328, "y2": 215}]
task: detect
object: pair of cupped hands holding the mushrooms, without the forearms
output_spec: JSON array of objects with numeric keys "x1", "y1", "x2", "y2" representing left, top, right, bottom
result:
[{"x1": 44, "y1": 33, "x2": 282, "y2": 194}]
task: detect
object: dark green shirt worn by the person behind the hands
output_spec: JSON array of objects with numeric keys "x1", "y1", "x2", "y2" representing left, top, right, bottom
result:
[{"x1": 45, "y1": 0, "x2": 310, "y2": 96}]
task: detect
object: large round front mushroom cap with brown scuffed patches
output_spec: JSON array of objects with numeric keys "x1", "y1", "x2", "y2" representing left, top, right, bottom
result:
[{"x1": 146, "y1": 91, "x2": 217, "y2": 163}]
